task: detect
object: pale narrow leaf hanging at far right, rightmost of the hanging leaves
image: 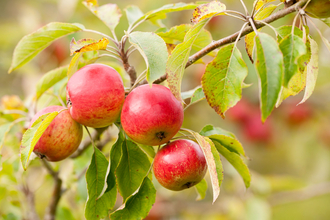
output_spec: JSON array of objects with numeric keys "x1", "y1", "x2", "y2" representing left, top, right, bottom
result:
[{"x1": 299, "y1": 37, "x2": 319, "y2": 104}]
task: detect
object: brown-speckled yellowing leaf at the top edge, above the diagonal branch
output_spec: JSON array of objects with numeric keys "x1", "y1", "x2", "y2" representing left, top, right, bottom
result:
[{"x1": 192, "y1": 1, "x2": 226, "y2": 24}]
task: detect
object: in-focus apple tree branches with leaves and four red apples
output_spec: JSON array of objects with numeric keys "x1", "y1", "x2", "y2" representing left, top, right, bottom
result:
[{"x1": 0, "y1": 0, "x2": 330, "y2": 220}]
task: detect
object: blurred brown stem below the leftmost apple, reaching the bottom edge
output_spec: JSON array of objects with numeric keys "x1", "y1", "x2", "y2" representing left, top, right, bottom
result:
[{"x1": 41, "y1": 159, "x2": 62, "y2": 220}]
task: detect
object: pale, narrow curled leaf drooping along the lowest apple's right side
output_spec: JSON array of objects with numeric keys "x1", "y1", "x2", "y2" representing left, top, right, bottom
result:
[{"x1": 187, "y1": 130, "x2": 223, "y2": 203}]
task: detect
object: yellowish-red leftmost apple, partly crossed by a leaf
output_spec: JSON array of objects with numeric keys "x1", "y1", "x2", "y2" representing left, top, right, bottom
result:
[{"x1": 30, "y1": 106, "x2": 83, "y2": 161}]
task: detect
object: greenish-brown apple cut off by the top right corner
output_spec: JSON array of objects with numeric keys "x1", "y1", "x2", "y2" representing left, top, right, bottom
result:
[{"x1": 305, "y1": 0, "x2": 330, "y2": 18}]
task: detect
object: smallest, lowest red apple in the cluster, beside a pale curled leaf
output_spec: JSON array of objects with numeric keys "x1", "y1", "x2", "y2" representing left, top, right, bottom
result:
[{"x1": 153, "y1": 139, "x2": 207, "y2": 191}]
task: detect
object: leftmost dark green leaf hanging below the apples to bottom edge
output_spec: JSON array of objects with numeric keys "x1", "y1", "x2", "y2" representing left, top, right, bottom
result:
[{"x1": 85, "y1": 147, "x2": 117, "y2": 220}]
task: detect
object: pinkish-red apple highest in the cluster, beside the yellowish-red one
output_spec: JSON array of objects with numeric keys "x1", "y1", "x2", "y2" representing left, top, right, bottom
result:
[{"x1": 67, "y1": 64, "x2": 125, "y2": 128}]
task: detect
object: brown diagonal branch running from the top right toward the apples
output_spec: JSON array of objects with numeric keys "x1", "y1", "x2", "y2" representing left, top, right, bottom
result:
[{"x1": 141, "y1": 0, "x2": 308, "y2": 84}]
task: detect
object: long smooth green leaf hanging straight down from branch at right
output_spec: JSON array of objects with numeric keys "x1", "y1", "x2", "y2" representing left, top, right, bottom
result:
[{"x1": 254, "y1": 33, "x2": 284, "y2": 121}]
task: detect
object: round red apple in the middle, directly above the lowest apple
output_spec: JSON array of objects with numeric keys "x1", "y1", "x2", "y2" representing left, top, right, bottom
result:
[{"x1": 121, "y1": 84, "x2": 183, "y2": 146}]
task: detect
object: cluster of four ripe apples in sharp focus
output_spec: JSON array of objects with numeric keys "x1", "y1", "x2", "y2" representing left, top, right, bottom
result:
[{"x1": 30, "y1": 64, "x2": 207, "y2": 190}]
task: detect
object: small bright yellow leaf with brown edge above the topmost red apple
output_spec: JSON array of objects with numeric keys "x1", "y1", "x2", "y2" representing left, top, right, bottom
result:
[{"x1": 70, "y1": 38, "x2": 109, "y2": 55}]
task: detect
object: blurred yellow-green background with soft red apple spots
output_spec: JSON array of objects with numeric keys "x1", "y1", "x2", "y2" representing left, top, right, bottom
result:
[{"x1": 0, "y1": 0, "x2": 330, "y2": 220}]
